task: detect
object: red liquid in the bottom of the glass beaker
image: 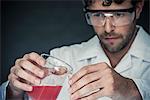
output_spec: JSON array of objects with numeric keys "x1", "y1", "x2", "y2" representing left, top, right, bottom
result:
[{"x1": 27, "y1": 86, "x2": 62, "y2": 100}]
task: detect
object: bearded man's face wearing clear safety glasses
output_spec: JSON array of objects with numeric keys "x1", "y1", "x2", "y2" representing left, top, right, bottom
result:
[{"x1": 87, "y1": 0, "x2": 142, "y2": 52}]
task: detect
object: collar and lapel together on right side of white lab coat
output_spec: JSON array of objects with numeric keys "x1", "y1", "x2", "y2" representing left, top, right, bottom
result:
[{"x1": 115, "y1": 26, "x2": 150, "y2": 73}]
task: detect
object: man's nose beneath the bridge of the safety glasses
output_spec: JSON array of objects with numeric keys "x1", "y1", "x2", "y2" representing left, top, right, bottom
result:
[{"x1": 104, "y1": 18, "x2": 115, "y2": 33}]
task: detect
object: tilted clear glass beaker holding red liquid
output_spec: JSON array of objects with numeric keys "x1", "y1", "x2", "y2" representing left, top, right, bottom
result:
[{"x1": 27, "y1": 54, "x2": 73, "y2": 100}]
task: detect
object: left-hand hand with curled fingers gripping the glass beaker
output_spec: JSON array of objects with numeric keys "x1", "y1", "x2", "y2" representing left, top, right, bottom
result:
[{"x1": 8, "y1": 52, "x2": 45, "y2": 96}]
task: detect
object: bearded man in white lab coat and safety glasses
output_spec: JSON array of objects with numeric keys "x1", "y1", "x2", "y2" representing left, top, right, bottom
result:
[{"x1": 1, "y1": 0, "x2": 150, "y2": 100}]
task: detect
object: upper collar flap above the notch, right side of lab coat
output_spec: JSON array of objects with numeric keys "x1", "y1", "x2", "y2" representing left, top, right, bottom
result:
[{"x1": 129, "y1": 26, "x2": 150, "y2": 62}]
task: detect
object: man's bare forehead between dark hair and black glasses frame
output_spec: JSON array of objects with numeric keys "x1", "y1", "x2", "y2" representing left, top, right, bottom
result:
[{"x1": 88, "y1": 0, "x2": 132, "y2": 10}]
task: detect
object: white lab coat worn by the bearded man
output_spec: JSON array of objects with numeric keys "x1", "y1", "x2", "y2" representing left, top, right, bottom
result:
[{"x1": 1, "y1": 26, "x2": 150, "y2": 100}]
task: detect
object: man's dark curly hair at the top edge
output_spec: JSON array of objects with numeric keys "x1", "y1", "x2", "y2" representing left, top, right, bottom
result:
[{"x1": 83, "y1": 0, "x2": 142, "y2": 7}]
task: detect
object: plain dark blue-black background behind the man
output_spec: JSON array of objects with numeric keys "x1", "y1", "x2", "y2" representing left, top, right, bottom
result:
[{"x1": 0, "y1": 0, "x2": 150, "y2": 84}]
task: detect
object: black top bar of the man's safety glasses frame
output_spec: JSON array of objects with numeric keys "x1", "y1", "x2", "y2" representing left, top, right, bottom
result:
[{"x1": 84, "y1": 7, "x2": 135, "y2": 13}]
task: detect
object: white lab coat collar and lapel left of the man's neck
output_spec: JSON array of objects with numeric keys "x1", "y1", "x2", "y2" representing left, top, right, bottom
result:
[{"x1": 77, "y1": 36, "x2": 110, "y2": 65}]
